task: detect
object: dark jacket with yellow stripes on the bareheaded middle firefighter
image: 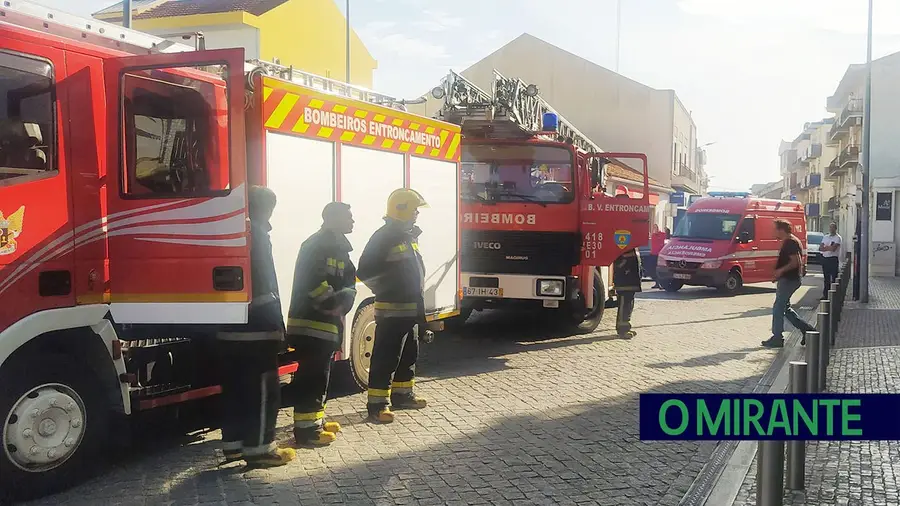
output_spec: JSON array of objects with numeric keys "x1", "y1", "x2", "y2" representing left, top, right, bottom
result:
[{"x1": 287, "y1": 228, "x2": 356, "y2": 345}]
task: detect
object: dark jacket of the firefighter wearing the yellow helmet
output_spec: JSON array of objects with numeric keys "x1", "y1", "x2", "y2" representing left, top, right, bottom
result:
[{"x1": 357, "y1": 218, "x2": 425, "y2": 321}]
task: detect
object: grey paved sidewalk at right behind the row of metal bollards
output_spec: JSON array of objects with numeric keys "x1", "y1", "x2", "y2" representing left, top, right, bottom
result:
[{"x1": 734, "y1": 278, "x2": 900, "y2": 506}]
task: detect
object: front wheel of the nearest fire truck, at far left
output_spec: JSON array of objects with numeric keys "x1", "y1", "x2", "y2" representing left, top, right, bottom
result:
[{"x1": 0, "y1": 355, "x2": 111, "y2": 503}]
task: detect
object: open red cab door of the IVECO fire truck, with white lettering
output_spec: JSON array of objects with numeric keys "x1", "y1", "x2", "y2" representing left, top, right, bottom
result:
[{"x1": 579, "y1": 153, "x2": 650, "y2": 267}]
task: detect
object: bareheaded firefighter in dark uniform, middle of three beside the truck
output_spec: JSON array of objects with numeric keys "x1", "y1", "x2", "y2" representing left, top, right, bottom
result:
[{"x1": 287, "y1": 202, "x2": 356, "y2": 446}]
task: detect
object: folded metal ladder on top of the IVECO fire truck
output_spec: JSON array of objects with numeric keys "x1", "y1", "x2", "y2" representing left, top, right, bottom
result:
[{"x1": 432, "y1": 70, "x2": 603, "y2": 153}]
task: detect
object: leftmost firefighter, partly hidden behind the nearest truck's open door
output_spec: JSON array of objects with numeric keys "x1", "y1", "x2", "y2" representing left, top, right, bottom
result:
[{"x1": 216, "y1": 186, "x2": 296, "y2": 467}]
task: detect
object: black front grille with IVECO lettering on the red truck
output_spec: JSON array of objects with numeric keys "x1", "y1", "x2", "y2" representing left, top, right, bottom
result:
[{"x1": 460, "y1": 230, "x2": 581, "y2": 276}]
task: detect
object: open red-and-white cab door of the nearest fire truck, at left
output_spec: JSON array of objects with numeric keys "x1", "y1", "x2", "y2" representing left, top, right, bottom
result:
[{"x1": 104, "y1": 49, "x2": 251, "y2": 325}]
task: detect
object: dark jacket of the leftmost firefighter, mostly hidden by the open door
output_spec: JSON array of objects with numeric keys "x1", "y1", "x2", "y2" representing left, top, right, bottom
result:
[{"x1": 218, "y1": 220, "x2": 284, "y2": 341}]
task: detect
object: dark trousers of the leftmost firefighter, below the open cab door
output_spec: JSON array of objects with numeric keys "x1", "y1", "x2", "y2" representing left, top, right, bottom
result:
[{"x1": 217, "y1": 339, "x2": 281, "y2": 456}]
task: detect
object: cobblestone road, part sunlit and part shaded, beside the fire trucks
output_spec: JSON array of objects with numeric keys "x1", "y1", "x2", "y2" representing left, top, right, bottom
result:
[{"x1": 26, "y1": 284, "x2": 814, "y2": 505}]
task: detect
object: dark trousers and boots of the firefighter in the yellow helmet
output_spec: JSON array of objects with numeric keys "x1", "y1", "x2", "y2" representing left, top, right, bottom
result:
[{"x1": 368, "y1": 317, "x2": 419, "y2": 407}]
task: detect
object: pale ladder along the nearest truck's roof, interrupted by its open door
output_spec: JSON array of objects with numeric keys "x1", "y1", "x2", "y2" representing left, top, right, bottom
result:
[{"x1": 0, "y1": 0, "x2": 410, "y2": 110}]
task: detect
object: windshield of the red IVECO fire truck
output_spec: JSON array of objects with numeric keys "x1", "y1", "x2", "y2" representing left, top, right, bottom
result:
[{"x1": 461, "y1": 144, "x2": 575, "y2": 204}]
